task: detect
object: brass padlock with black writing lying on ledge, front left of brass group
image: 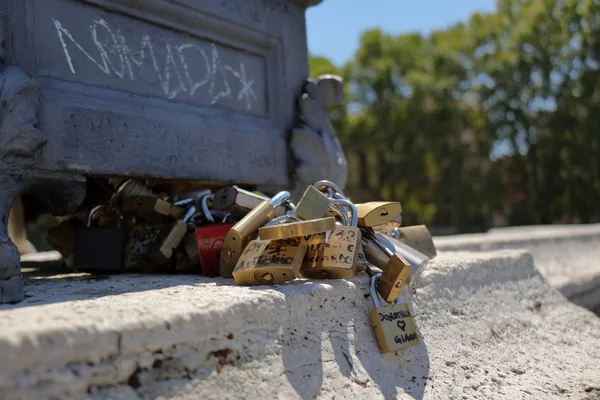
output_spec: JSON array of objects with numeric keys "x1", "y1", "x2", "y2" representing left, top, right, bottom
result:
[{"x1": 233, "y1": 237, "x2": 306, "y2": 285}]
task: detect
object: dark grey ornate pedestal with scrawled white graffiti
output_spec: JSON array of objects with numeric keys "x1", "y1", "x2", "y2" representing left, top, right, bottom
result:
[{"x1": 0, "y1": 0, "x2": 345, "y2": 302}]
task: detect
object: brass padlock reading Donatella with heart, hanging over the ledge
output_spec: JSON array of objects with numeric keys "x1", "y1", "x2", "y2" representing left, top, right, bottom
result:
[{"x1": 370, "y1": 274, "x2": 421, "y2": 353}]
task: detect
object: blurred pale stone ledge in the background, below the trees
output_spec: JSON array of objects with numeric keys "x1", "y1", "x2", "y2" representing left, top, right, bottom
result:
[{"x1": 434, "y1": 224, "x2": 600, "y2": 314}]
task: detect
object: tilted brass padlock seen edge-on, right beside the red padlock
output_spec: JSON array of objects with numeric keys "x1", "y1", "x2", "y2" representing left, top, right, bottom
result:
[{"x1": 220, "y1": 191, "x2": 290, "y2": 278}]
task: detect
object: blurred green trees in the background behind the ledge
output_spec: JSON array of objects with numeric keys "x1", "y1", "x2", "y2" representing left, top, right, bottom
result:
[{"x1": 311, "y1": 0, "x2": 600, "y2": 232}]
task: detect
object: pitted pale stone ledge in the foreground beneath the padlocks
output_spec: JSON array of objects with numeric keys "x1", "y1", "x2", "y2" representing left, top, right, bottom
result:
[{"x1": 0, "y1": 251, "x2": 600, "y2": 400}]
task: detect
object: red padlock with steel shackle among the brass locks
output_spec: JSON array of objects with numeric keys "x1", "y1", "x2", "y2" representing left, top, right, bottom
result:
[{"x1": 196, "y1": 196, "x2": 234, "y2": 278}]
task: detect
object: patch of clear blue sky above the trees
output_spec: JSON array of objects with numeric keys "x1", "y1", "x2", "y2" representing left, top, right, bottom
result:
[{"x1": 307, "y1": 0, "x2": 496, "y2": 65}]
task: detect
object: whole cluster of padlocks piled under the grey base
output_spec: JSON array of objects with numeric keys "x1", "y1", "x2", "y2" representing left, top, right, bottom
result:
[{"x1": 43, "y1": 180, "x2": 436, "y2": 352}]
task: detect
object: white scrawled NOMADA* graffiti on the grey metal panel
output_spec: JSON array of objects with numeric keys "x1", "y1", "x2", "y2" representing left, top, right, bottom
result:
[{"x1": 52, "y1": 18, "x2": 257, "y2": 111}]
